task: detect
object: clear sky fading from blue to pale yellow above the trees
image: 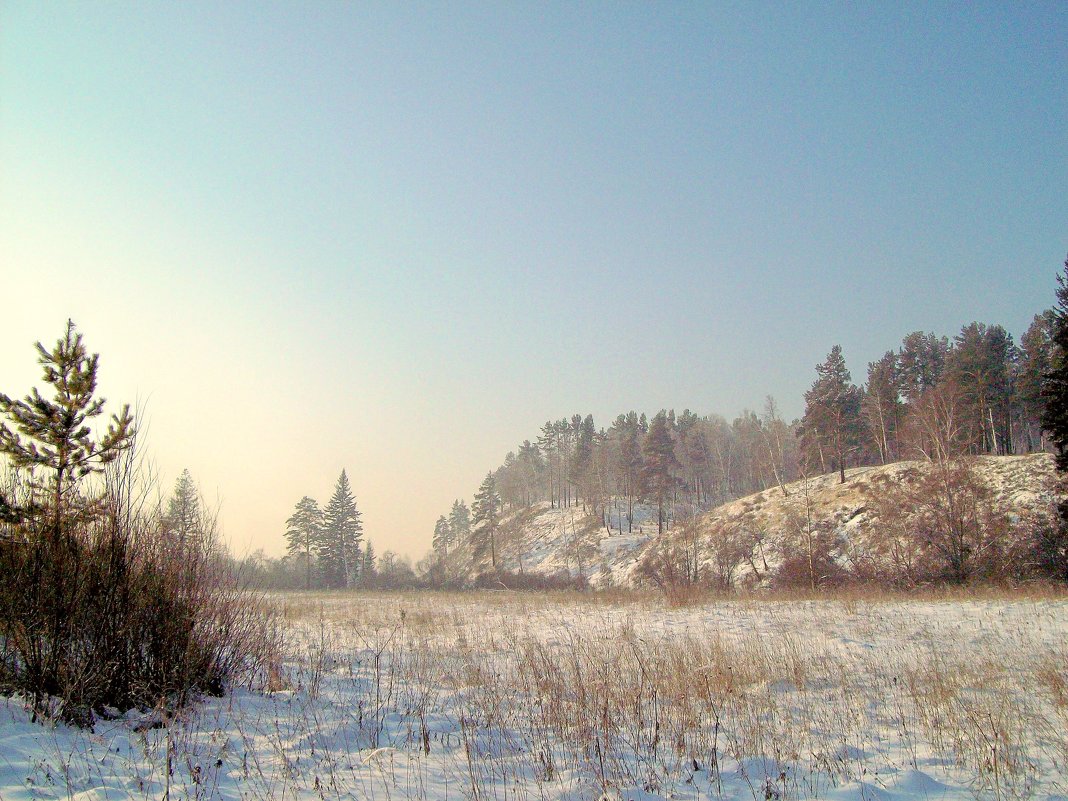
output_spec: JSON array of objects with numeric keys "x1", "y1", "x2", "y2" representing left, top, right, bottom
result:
[{"x1": 0, "y1": 0, "x2": 1068, "y2": 557}]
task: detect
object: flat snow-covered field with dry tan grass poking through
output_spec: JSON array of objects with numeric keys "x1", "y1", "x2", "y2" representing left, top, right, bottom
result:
[{"x1": 0, "y1": 593, "x2": 1068, "y2": 801}]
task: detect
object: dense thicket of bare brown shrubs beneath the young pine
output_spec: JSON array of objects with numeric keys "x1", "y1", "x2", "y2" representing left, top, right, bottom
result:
[{"x1": 0, "y1": 442, "x2": 280, "y2": 725}]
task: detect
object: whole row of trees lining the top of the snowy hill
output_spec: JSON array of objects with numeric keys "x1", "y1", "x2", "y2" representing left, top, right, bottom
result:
[{"x1": 434, "y1": 299, "x2": 1068, "y2": 563}]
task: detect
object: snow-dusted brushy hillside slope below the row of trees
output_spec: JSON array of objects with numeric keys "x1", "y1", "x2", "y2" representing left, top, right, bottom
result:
[{"x1": 427, "y1": 454, "x2": 1065, "y2": 591}]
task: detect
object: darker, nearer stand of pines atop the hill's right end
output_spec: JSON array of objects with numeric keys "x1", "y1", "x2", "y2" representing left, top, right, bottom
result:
[{"x1": 798, "y1": 311, "x2": 1054, "y2": 481}]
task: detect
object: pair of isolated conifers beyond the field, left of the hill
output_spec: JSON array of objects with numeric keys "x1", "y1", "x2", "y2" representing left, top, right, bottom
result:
[{"x1": 285, "y1": 470, "x2": 376, "y2": 590}]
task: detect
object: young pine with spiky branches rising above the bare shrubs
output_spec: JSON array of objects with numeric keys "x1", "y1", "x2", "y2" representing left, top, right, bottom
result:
[{"x1": 0, "y1": 320, "x2": 135, "y2": 539}]
